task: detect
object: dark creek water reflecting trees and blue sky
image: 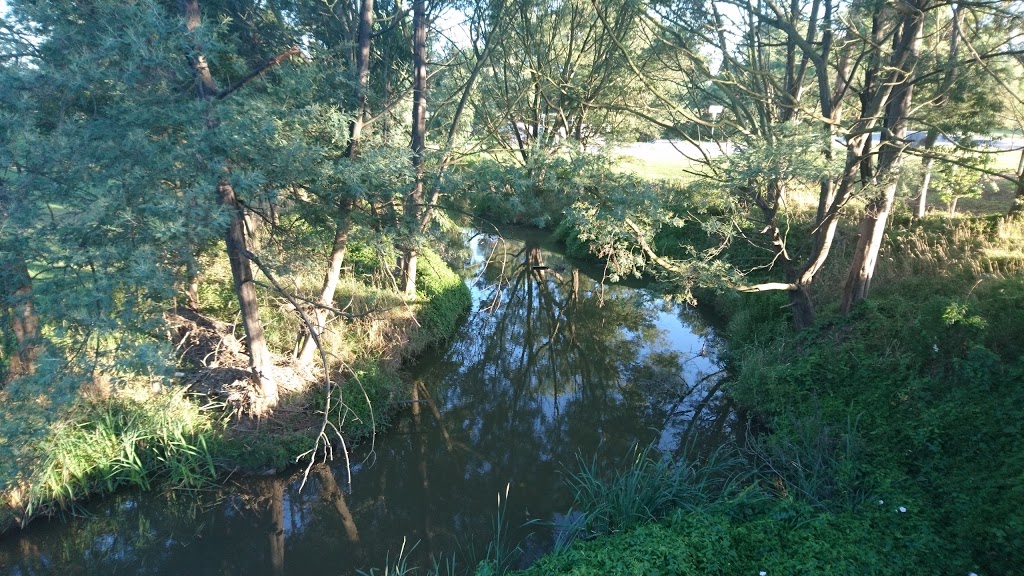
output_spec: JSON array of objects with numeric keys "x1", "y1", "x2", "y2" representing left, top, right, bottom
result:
[{"x1": 0, "y1": 228, "x2": 734, "y2": 576}]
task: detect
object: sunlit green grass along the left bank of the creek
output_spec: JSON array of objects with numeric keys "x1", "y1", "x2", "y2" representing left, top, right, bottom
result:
[{"x1": 0, "y1": 243, "x2": 470, "y2": 532}]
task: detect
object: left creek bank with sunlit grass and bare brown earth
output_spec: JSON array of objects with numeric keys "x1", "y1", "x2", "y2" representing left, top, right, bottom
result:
[{"x1": 0, "y1": 242, "x2": 470, "y2": 533}]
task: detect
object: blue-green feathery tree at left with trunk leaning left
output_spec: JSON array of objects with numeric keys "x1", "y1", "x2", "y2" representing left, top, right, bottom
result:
[{"x1": 0, "y1": 0, "x2": 335, "y2": 407}]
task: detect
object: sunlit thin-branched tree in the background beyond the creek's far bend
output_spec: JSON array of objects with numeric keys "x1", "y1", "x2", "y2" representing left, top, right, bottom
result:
[{"x1": 474, "y1": 0, "x2": 659, "y2": 165}]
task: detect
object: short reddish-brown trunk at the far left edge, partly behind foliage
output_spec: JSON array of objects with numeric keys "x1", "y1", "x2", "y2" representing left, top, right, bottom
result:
[{"x1": 0, "y1": 254, "x2": 43, "y2": 384}]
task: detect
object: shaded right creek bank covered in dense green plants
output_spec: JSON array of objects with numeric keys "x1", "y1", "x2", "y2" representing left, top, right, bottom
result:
[{"x1": 509, "y1": 216, "x2": 1024, "y2": 575}]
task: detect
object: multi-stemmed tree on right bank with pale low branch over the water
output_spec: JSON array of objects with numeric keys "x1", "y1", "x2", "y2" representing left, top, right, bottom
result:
[{"x1": 581, "y1": 0, "x2": 903, "y2": 327}]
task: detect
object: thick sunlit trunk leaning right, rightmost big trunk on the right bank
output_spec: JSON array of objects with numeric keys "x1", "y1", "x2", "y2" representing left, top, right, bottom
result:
[{"x1": 841, "y1": 0, "x2": 929, "y2": 314}]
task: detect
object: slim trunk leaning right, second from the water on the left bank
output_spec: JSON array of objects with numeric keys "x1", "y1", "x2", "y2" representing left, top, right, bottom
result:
[{"x1": 295, "y1": 0, "x2": 374, "y2": 362}]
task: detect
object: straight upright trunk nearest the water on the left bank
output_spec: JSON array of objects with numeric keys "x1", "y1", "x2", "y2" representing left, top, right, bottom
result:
[{"x1": 401, "y1": 0, "x2": 427, "y2": 296}]
